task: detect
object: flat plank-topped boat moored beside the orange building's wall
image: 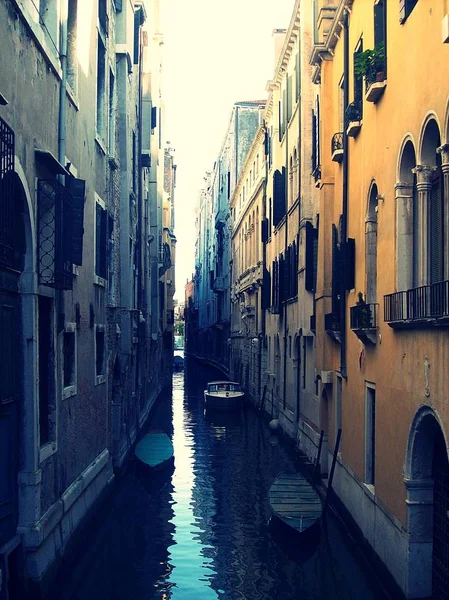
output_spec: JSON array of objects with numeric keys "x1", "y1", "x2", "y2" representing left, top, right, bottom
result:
[{"x1": 269, "y1": 473, "x2": 322, "y2": 533}]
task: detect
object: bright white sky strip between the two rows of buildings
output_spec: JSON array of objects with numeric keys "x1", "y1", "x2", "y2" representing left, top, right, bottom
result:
[{"x1": 160, "y1": 0, "x2": 295, "y2": 301}]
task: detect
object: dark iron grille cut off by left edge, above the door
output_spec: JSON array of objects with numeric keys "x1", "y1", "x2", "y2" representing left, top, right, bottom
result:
[{"x1": 0, "y1": 119, "x2": 14, "y2": 268}]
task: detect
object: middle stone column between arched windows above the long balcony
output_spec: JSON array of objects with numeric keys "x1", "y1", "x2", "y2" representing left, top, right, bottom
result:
[{"x1": 412, "y1": 165, "x2": 436, "y2": 286}]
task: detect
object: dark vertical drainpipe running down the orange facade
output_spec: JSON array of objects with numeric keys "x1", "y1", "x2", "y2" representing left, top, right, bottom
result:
[{"x1": 339, "y1": 9, "x2": 349, "y2": 379}]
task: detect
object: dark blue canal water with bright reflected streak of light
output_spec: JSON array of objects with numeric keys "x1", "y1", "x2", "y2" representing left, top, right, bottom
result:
[{"x1": 53, "y1": 363, "x2": 385, "y2": 600}]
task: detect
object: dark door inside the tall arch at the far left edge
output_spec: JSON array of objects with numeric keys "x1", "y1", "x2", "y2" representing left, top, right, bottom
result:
[{"x1": 0, "y1": 270, "x2": 19, "y2": 548}]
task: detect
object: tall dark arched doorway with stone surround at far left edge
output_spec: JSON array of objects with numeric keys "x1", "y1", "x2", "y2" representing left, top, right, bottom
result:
[{"x1": 0, "y1": 155, "x2": 39, "y2": 585}]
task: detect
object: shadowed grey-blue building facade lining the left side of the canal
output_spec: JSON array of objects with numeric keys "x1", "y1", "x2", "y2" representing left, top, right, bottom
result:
[{"x1": 0, "y1": 0, "x2": 170, "y2": 600}]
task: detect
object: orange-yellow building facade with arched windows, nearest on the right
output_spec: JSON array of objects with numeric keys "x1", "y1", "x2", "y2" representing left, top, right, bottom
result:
[{"x1": 311, "y1": 0, "x2": 449, "y2": 598}]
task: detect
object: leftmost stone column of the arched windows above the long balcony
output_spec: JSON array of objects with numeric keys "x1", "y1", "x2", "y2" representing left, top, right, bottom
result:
[{"x1": 394, "y1": 182, "x2": 417, "y2": 291}]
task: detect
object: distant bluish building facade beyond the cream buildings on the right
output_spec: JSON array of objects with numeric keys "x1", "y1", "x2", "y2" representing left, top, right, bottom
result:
[{"x1": 186, "y1": 100, "x2": 265, "y2": 373}]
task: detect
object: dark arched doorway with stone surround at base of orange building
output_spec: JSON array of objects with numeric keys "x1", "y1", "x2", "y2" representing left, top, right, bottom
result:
[{"x1": 404, "y1": 405, "x2": 449, "y2": 600}]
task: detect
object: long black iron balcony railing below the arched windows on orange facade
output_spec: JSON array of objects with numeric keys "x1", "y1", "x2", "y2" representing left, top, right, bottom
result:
[{"x1": 384, "y1": 281, "x2": 449, "y2": 327}]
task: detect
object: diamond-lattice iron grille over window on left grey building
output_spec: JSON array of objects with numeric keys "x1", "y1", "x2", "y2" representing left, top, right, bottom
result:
[{"x1": 38, "y1": 179, "x2": 73, "y2": 290}]
